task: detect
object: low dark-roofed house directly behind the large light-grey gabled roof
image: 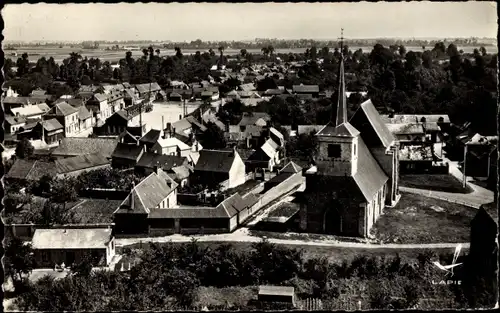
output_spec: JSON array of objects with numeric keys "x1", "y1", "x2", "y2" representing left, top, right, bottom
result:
[{"x1": 135, "y1": 152, "x2": 188, "y2": 176}]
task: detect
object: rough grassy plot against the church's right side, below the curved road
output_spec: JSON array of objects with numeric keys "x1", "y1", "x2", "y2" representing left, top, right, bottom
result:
[{"x1": 372, "y1": 193, "x2": 477, "y2": 244}]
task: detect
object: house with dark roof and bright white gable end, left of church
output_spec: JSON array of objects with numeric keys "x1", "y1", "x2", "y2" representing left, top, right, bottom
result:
[{"x1": 193, "y1": 149, "x2": 245, "y2": 188}]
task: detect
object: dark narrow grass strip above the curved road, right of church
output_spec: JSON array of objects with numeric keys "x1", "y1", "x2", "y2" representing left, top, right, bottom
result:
[{"x1": 399, "y1": 174, "x2": 473, "y2": 193}]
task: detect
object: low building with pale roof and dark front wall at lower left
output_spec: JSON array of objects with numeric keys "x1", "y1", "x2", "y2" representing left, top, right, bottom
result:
[{"x1": 31, "y1": 228, "x2": 115, "y2": 268}]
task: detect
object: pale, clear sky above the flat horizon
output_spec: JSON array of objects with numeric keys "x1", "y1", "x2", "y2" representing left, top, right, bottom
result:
[{"x1": 2, "y1": 1, "x2": 498, "y2": 41}]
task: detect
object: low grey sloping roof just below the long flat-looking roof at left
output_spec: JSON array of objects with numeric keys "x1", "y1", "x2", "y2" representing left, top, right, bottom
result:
[{"x1": 55, "y1": 153, "x2": 111, "y2": 177}]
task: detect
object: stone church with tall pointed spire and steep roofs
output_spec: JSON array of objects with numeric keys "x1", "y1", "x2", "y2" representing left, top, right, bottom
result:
[{"x1": 299, "y1": 48, "x2": 400, "y2": 237}]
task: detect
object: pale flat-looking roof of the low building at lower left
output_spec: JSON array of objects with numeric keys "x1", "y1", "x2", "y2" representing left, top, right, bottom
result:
[{"x1": 31, "y1": 228, "x2": 112, "y2": 249}]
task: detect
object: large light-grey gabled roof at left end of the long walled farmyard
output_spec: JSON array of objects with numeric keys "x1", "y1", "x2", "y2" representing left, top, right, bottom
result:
[{"x1": 115, "y1": 170, "x2": 178, "y2": 213}]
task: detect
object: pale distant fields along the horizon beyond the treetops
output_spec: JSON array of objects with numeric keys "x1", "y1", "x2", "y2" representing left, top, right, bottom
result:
[{"x1": 5, "y1": 45, "x2": 498, "y2": 63}]
